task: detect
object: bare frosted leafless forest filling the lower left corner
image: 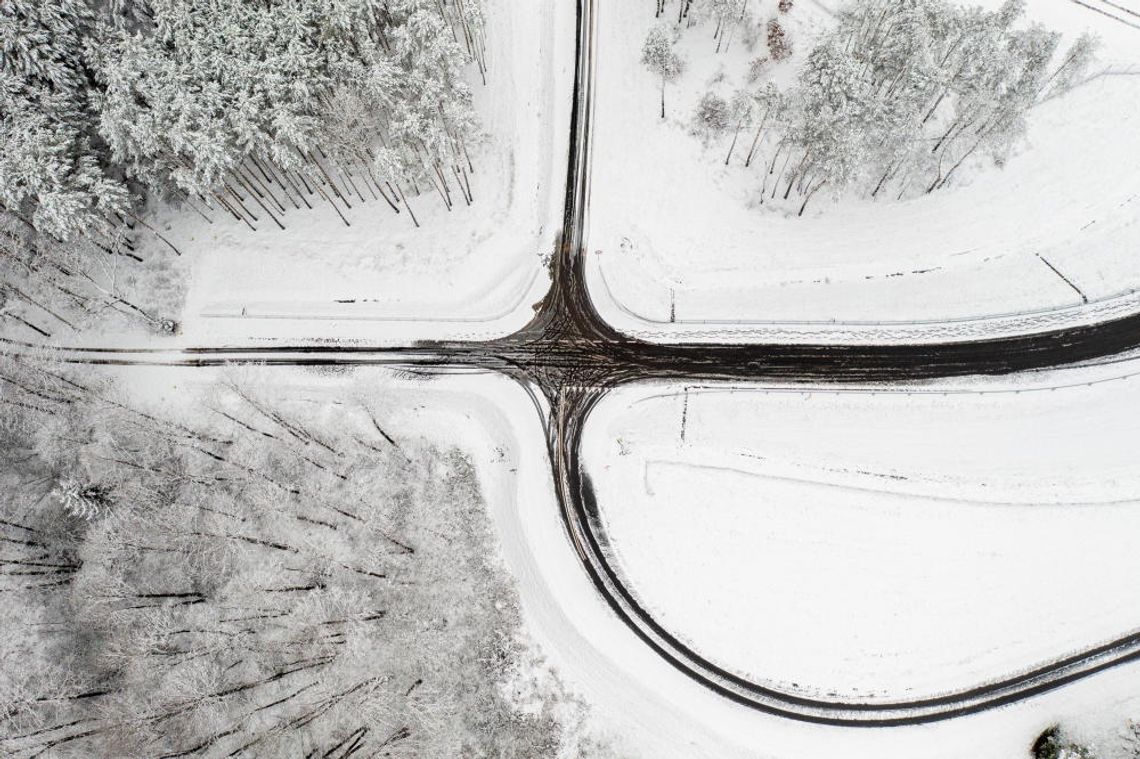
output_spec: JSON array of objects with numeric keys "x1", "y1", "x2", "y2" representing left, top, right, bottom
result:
[{"x1": 0, "y1": 359, "x2": 611, "y2": 759}]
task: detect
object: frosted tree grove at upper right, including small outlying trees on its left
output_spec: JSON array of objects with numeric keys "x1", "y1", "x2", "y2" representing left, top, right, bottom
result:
[{"x1": 643, "y1": 0, "x2": 1097, "y2": 214}]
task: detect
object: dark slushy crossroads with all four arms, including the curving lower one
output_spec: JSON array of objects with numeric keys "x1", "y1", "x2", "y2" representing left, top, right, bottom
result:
[{"x1": 7, "y1": 0, "x2": 1140, "y2": 726}]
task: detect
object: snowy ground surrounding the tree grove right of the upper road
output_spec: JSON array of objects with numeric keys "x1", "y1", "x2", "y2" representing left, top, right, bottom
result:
[{"x1": 589, "y1": 0, "x2": 1140, "y2": 340}]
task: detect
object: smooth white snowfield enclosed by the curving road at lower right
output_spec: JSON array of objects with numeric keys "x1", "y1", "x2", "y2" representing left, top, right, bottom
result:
[{"x1": 586, "y1": 366, "x2": 1140, "y2": 699}]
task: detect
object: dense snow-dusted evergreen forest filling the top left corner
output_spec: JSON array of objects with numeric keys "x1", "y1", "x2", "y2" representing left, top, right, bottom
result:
[{"x1": 0, "y1": 0, "x2": 486, "y2": 336}]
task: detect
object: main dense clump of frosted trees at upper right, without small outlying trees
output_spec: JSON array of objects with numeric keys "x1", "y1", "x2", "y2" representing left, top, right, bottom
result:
[{"x1": 746, "y1": 0, "x2": 1096, "y2": 212}]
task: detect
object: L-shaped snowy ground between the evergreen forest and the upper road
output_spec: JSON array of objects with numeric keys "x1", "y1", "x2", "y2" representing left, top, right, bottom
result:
[{"x1": 152, "y1": 0, "x2": 575, "y2": 343}]
